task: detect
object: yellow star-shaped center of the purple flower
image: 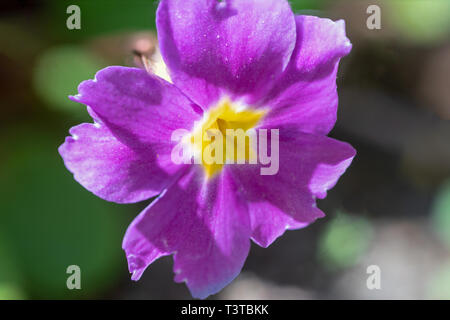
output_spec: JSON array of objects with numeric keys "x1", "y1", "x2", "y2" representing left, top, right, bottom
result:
[{"x1": 189, "y1": 99, "x2": 266, "y2": 178}]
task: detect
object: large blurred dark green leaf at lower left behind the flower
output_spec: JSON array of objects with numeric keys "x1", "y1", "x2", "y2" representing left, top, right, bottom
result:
[{"x1": 0, "y1": 131, "x2": 127, "y2": 298}]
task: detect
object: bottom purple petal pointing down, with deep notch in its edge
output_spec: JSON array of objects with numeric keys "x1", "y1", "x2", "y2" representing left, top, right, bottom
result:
[{"x1": 123, "y1": 167, "x2": 250, "y2": 298}]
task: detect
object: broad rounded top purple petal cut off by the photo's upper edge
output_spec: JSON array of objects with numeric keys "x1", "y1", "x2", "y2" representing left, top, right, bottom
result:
[{"x1": 156, "y1": 0, "x2": 296, "y2": 108}]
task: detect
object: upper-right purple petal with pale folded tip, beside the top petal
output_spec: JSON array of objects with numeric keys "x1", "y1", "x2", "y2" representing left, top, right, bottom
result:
[{"x1": 262, "y1": 16, "x2": 352, "y2": 134}]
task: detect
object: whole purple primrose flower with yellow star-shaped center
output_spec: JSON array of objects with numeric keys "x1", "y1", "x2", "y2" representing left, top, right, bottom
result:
[{"x1": 59, "y1": 0, "x2": 355, "y2": 298}]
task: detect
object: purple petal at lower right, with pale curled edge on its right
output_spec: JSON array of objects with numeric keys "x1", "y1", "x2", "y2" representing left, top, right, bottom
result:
[{"x1": 233, "y1": 133, "x2": 355, "y2": 247}]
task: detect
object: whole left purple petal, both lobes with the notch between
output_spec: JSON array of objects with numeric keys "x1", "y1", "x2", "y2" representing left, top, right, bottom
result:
[{"x1": 65, "y1": 67, "x2": 202, "y2": 203}]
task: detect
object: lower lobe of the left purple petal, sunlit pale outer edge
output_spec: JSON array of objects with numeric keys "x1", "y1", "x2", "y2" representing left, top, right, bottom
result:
[{"x1": 59, "y1": 123, "x2": 171, "y2": 203}]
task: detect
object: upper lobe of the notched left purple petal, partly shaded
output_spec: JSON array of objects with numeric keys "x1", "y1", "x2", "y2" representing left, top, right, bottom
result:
[{"x1": 71, "y1": 67, "x2": 201, "y2": 150}]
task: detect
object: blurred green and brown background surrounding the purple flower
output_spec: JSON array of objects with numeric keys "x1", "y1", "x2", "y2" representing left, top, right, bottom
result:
[{"x1": 0, "y1": 0, "x2": 450, "y2": 299}]
